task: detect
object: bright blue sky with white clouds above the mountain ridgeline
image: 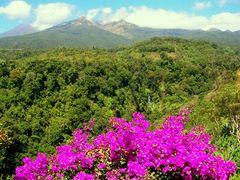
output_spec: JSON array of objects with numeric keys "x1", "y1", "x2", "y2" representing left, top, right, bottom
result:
[{"x1": 0, "y1": 0, "x2": 240, "y2": 32}]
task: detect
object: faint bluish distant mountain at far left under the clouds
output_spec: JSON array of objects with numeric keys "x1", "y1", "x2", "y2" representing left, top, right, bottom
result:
[{"x1": 0, "y1": 24, "x2": 37, "y2": 38}]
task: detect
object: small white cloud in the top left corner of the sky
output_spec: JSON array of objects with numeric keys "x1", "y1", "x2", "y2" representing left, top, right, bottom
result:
[{"x1": 0, "y1": 0, "x2": 31, "y2": 19}]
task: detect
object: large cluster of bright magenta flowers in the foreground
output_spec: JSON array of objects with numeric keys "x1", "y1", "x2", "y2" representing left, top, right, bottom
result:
[{"x1": 15, "y1": 110, "x2": 236, "y2": 180}]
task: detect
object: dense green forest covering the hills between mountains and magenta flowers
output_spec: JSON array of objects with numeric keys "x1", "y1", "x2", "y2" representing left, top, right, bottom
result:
[{"x1": 0, "y1": 38, "x2": 240, "y2": 178}]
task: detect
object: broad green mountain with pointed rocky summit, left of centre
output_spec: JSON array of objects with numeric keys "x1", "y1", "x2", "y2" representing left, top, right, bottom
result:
[{"x1": 0, "y1": 18, "x2": 131, "y2": 49}]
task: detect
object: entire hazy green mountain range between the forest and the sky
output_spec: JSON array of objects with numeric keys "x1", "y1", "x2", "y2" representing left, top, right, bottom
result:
[{"x1": 0, "y1": 17, "x2": 240, "y2": 49}]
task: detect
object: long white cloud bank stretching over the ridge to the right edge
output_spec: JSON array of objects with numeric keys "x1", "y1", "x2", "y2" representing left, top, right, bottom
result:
[{"x1": 93, "y1": 6, "x2": 240, "y2": 31}]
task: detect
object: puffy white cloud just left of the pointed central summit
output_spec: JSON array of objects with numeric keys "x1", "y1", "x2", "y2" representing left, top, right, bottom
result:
[{"x1": 33, "y1": 3, "x2": 74, "y2": 30}]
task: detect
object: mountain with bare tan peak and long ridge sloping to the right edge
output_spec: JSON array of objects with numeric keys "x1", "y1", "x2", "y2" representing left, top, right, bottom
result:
[{"x1": 102, "y1": 20, "x2": 240, "y2": 46}]
